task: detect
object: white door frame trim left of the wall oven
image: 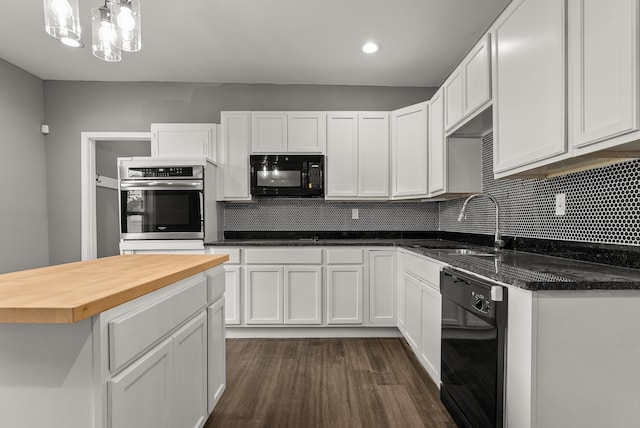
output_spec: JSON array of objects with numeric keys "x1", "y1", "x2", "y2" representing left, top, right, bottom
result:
[{"x1": 80, "y1": 132, "x2": 151, "y2": 260}]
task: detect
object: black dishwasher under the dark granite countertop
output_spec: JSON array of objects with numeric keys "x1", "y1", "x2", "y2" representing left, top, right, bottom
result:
[{"x1": 440, "y1": 268, "x2": 507, "y2": 428}]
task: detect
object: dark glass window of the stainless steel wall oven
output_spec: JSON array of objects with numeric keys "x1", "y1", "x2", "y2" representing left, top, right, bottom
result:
[{"x1": 121, "y1": 190, "x2": 202, "y2": 233}]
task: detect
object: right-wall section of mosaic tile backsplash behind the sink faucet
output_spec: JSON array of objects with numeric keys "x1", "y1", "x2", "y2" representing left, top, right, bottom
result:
[{"x1": 439, "y1": 134, "x2": 640, "y2": 245}]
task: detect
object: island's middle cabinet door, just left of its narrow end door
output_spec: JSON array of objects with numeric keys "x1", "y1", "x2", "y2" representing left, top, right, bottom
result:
[{"x1": 172, "y1": 311, "x2": 208, "y2": 428}]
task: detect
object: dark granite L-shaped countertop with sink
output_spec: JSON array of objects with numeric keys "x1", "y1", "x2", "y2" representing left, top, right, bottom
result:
[{"x1": 205, "y1": 237, "x2": 640, "y2": 291}]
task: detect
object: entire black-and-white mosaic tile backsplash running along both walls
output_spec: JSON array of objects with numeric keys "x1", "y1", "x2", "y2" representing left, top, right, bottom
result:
[{"x1": 224, "y1": 134, "x2": 640, "y2": 246}]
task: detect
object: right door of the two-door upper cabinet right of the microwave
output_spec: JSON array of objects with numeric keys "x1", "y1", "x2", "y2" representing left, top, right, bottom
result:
[{"x1": 358, "y1": 113, "x2": 389, "y2": 199}]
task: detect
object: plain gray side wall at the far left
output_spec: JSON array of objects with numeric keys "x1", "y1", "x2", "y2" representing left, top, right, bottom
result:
[{"x1": 0, "y1": 59, "x2": 49, "y2": 273}]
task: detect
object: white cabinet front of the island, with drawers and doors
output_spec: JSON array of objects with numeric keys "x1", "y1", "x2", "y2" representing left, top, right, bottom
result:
[{"x1": 102, "y1": 266, "x2": 226, "y2": 428}]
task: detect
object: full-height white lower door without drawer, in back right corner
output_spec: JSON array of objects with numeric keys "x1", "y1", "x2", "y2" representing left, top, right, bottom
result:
[{"x1": 369, "y1": 250, "x2": 398, "y2": 323}]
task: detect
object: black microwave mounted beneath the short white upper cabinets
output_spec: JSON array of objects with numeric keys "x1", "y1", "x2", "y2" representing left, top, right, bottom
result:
[{"x1": 249, "y1": 154, "x2": 324, "y2": 197}]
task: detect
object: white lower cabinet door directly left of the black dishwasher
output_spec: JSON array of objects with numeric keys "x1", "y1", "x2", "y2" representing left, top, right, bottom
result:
[{"x1": 420, "y1": 285, "x2": 442, "y2": 384}]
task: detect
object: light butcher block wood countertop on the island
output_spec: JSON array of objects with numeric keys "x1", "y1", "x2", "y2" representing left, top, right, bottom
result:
[{"x1": 0, "y1": 254, "x2": 229, "y2": 324}]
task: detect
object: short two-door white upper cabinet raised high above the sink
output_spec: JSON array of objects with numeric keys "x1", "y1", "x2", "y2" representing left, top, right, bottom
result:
[{"x1": 442, "y1": 34, "x2": 491, "y2": 131}]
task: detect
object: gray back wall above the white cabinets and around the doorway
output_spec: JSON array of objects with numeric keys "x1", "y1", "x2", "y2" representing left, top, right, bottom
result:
[{"x1": 44, "y1": 81, "x2": 437, "y2": 264}]
